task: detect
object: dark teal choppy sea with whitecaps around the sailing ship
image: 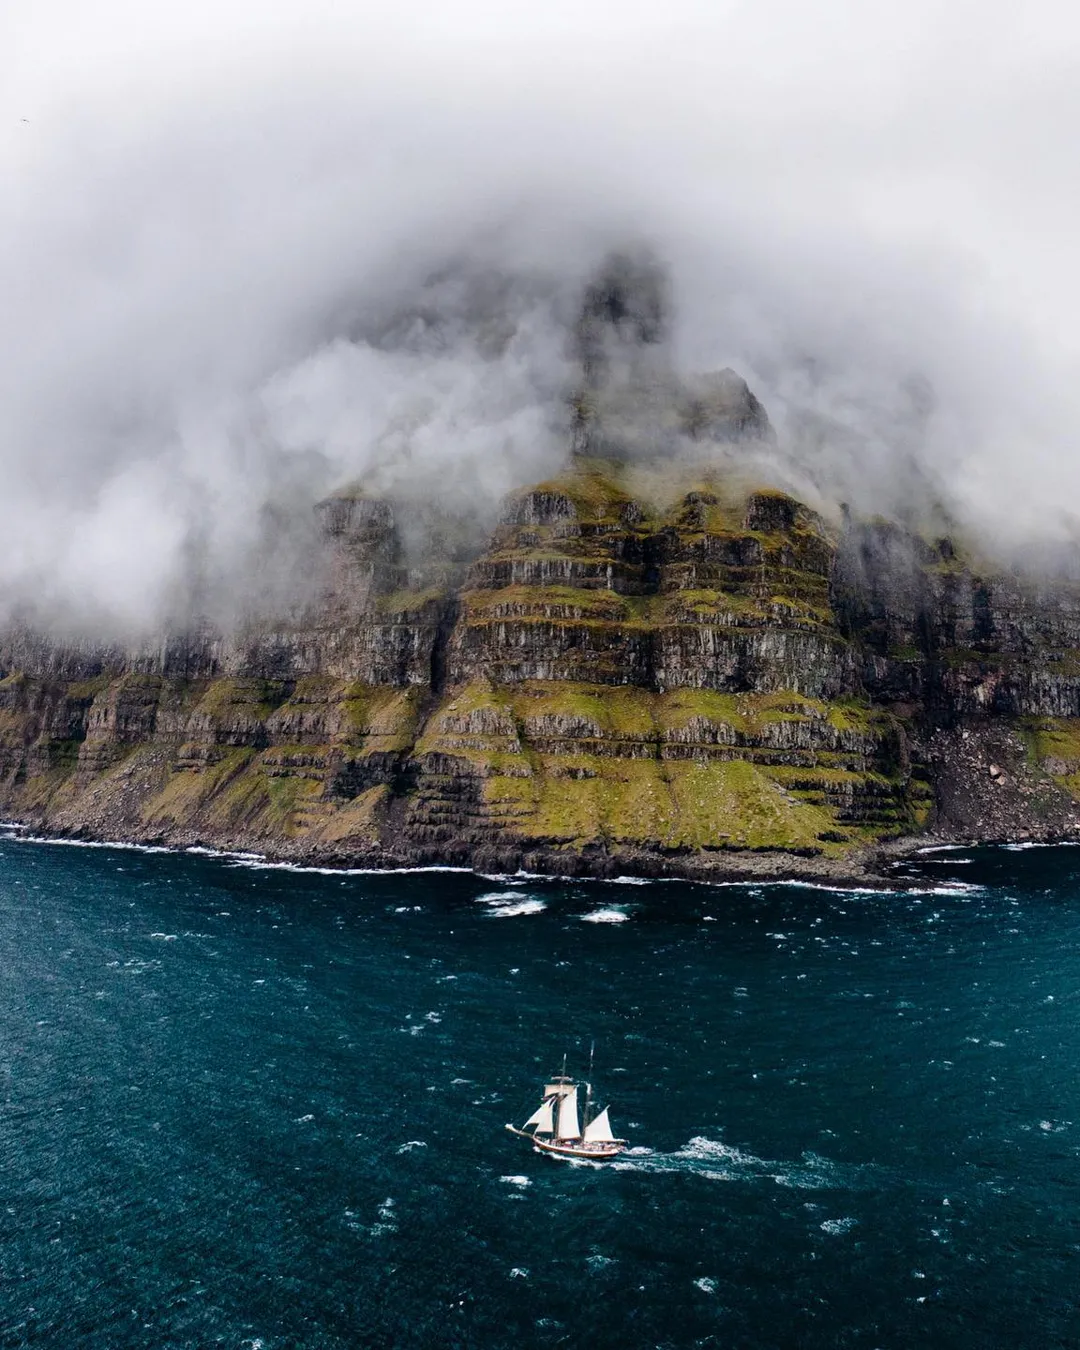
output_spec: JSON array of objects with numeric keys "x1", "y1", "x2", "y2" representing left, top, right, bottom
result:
[{"x1": 0, "y1": 837, "x2": 1080, "y2": 1350}]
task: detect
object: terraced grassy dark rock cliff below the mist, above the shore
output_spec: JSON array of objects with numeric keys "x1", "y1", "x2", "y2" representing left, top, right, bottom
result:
[{"x1": 0, "y1": 442, "x2": 1080, "y2": 878}]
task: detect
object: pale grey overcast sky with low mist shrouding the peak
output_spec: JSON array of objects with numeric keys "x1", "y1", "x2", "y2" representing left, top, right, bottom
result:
[{"x1": 0, "y1": 0, "x2": 1080, "y2": 624}]
